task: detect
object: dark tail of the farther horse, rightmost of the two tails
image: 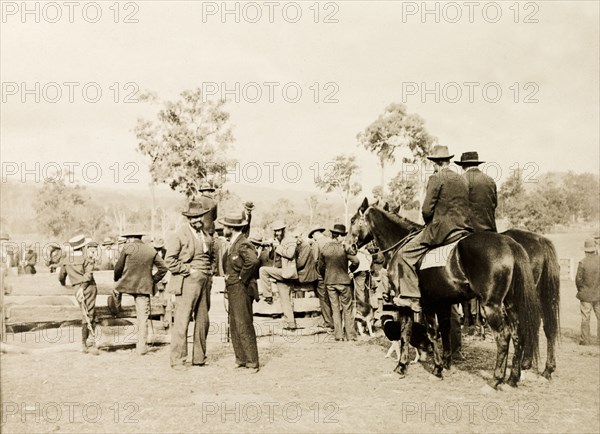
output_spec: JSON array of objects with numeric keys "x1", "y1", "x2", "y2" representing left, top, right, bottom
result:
[{"x1": 538, "y1": 237, "x2": 560, "y2": 342}]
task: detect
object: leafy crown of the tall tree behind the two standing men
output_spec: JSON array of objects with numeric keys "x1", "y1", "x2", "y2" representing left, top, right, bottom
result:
[{"x1": 135, "y1": 89, "x2": 233, "y2": 198}]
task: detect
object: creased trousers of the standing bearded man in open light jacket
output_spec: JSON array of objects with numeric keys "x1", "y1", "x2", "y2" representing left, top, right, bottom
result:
[{"x1": 171, "y1": 271, "x2": 212, "y2": 366}]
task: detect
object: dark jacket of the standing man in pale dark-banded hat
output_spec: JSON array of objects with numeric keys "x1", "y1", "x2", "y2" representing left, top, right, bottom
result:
[{"x1": 224, "y1": 234, "x2": 259, "y2": 288}]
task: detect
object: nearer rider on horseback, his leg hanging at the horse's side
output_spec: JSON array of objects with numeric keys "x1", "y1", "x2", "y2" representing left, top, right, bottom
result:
[{"x1": 389, "y1": 145, "x2": 471, "y2": 298}]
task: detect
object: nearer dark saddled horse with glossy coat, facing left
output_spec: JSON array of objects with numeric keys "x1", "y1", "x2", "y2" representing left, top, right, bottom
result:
[{"x1": 350, "y1": 199, "x2": 541, "y2": 388}]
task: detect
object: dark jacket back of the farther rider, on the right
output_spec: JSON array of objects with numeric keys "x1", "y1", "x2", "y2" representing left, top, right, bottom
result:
[{"x1": 462, "y1": 168, "x2": 498, "y2": 232}]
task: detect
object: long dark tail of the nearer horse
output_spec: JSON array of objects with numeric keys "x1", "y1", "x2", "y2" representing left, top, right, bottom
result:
[{"x1": 510, "y1": 242, "x2": 541, "y2": 362}]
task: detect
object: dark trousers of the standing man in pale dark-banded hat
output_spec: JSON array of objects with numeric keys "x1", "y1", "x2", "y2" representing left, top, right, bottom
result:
[{"x1": 227, "y1": 282, "x2": 258, "y2": 368}]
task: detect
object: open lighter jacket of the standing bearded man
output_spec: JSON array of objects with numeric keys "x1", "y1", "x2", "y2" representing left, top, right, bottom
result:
[{"x1": 165, "y1": 224, "x2": 214, "y2": 294}]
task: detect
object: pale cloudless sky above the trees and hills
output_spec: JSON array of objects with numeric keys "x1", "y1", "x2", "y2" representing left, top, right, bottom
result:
[{"x1": 0, "y1": 1, "x2": 600, "y2": 192}]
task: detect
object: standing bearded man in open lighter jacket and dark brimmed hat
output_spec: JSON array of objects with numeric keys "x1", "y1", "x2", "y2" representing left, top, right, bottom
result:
[{"x1": 165, "y1": 202, "x2": 214, "y2": 370}]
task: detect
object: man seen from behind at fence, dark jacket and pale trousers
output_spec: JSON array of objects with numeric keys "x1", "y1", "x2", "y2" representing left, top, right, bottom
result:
[{"x1": 113, "y1": 232, "x2": 167, "y2": 356}]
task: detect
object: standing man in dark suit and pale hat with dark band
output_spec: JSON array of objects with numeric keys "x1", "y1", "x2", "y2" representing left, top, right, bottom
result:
[{"x1": 219, "y1": 213, "x2": 259, "y2": 373}]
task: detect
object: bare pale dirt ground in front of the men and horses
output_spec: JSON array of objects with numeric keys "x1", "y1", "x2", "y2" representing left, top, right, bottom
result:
[{"x1": 0, "y1": 234, "x2": 600, "y2": 433}]
